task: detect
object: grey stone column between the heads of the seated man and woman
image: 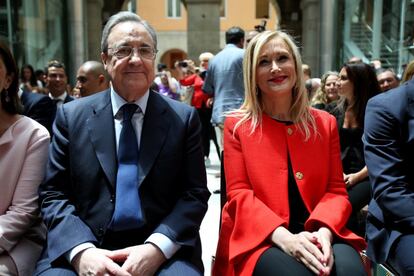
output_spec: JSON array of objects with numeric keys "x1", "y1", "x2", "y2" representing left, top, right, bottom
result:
[{"x1": 185, "y1": 0, "x2": 220, "y2": 64}]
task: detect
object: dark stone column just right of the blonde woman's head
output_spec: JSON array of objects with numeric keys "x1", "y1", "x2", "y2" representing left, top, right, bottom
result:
[{"x1": 302, "y1": 0, "x2": 321, "y2": 77}]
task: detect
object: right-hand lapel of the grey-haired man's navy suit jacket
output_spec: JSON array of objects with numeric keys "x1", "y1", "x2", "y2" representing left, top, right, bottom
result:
[{"x1": 139, "y1": 92, "x2": 170, "y2": 185}]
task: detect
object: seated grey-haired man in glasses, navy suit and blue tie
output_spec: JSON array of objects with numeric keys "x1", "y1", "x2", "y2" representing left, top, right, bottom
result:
[{"x1": 36, "y1": 12, "x2": 210, "y2": 275}]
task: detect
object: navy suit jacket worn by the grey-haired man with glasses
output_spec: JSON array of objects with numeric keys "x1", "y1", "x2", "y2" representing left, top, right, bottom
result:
[{"x1": 38, "y1": 90, "x2": 210, "y2": 271}]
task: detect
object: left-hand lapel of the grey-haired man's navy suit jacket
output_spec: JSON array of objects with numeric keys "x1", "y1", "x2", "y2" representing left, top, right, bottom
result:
[{"x1": 87, "y1": 90, "x2": 117, "y2": 187}]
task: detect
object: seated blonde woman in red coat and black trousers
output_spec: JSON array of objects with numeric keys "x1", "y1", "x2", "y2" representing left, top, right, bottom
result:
[{"x1": 213, "y1": 31, "x2": 366, "y2": 276}]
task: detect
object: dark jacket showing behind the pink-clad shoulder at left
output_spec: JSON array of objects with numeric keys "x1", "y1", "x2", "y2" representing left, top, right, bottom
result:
[{"x1": 20, "y1": 91, "x2": 56, "y2": 134}]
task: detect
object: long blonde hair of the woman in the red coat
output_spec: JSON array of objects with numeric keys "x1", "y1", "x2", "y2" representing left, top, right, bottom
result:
[{"x1": 231, "y1": 31, "x2": 316, "y2": 140}]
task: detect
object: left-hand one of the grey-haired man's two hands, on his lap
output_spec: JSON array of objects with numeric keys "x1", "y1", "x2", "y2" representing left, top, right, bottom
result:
[{"x1": 72, "y1": 248, "x2": 131, "y2": 276}]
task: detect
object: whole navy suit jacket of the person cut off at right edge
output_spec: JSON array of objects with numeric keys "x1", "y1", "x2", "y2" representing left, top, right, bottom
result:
[{"x1": 363, "y1": 81, "x2": 414, "y2": 263}]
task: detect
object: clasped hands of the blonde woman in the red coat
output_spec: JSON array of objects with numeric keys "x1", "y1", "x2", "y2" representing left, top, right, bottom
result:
[{"x1": 271, "y1": 226, "x2": 332, "y2": 275}]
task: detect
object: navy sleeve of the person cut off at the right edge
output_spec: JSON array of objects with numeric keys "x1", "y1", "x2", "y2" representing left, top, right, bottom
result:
[{"x1": 363, "y1": 88, "x2": 414, "y2": 229}]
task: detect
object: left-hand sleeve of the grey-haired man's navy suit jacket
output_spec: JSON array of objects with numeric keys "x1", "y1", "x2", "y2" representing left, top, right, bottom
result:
[{"x1": 40, "y1": 105, "x2": 97, "y2": 262}]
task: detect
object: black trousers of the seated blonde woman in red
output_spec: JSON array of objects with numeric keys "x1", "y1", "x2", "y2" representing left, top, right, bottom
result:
[{"x1": 253, "y1": 243, "x2": 366, "y2": 276}]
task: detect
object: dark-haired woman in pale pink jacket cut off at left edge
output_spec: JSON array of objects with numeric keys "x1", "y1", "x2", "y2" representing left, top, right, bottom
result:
[{"x1": 0, "y1": 42, "x2": 49, "y2": 276}]
